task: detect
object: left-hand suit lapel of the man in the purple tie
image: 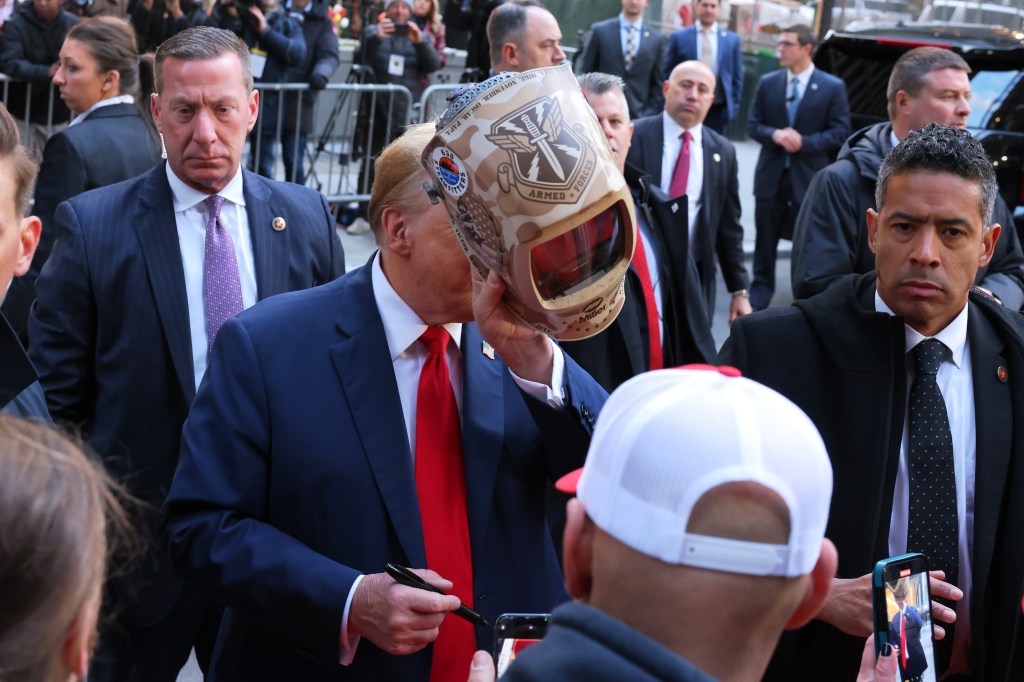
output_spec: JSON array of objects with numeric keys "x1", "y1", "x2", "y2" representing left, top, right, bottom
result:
[{"x1": 131, "y1": 164, "x2": 196, "y2": 404}]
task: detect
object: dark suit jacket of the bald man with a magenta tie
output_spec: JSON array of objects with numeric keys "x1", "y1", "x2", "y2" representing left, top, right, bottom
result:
[{"x1": 626, "y1": 114, "x2": 750, "y2": 318}]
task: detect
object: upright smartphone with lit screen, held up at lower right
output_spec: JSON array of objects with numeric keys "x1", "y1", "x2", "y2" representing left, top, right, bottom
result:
[{"x1": 871, "y1": 554, "x2": 936, "y2": 682}]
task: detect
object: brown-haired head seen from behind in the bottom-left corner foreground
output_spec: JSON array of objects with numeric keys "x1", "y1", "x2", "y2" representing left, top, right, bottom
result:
[{"x1": 0, "y1": 414, "x2": 128, "y2": 682}]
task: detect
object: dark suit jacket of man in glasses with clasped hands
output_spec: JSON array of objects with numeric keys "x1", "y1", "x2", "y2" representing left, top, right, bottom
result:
[{"x1": 746, "y1": 69, "x2": 850, "y2": 203}]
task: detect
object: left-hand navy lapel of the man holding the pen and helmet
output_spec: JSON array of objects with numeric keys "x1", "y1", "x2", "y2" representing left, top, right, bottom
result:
[{"x1": 331, "y1": 266, "x2": 427, "y2": 566}]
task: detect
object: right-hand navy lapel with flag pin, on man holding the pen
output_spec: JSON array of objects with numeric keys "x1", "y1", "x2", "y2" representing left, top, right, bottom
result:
[{"x1": 461, "y1": 324, "x2": 507, "y2": 548}]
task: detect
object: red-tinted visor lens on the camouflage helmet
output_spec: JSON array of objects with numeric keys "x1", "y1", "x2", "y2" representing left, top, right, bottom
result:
[{"x1": 529, "y1": 203, "x2": 626, "y2": 300}]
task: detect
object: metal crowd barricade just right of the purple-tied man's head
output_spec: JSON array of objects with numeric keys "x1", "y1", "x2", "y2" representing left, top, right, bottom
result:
[{"x1": 246, "y1": 83, "x2": 416, "y2": 204}]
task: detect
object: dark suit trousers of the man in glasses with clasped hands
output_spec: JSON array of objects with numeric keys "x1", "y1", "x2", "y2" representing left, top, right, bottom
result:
[{"x1": 751, "y1": 170, "x2": 800, "y2": 310}]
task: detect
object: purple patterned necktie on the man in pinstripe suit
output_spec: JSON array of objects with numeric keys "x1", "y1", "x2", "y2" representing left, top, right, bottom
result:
[{"x1": 203, "y1": 195, "x2": 242, "y2": 348}]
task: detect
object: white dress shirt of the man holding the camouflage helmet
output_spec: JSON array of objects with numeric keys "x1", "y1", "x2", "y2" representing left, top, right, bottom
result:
[{"x1": 339, "y1": 252, "x2": 565, "y2": 666}]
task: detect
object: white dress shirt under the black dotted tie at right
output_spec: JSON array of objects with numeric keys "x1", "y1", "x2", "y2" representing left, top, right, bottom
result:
[{"x1": 874, "y1": 292, "x2": 977, "y2": 673}]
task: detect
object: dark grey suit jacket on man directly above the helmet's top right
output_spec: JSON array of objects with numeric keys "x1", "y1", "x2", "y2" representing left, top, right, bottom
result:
[{"x1": 575, "y1": 16, "x2": 665, "y2": 119}]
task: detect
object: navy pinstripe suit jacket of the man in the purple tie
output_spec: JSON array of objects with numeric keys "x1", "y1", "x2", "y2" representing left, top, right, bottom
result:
[{"x1": 29, "y1": 164, "x2": 344, "y2": 625}]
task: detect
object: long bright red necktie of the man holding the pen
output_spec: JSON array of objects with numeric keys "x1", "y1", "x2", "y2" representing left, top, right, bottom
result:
[{"x1": 416, "y1": 327, "x2": 476, "y2": 682}]
